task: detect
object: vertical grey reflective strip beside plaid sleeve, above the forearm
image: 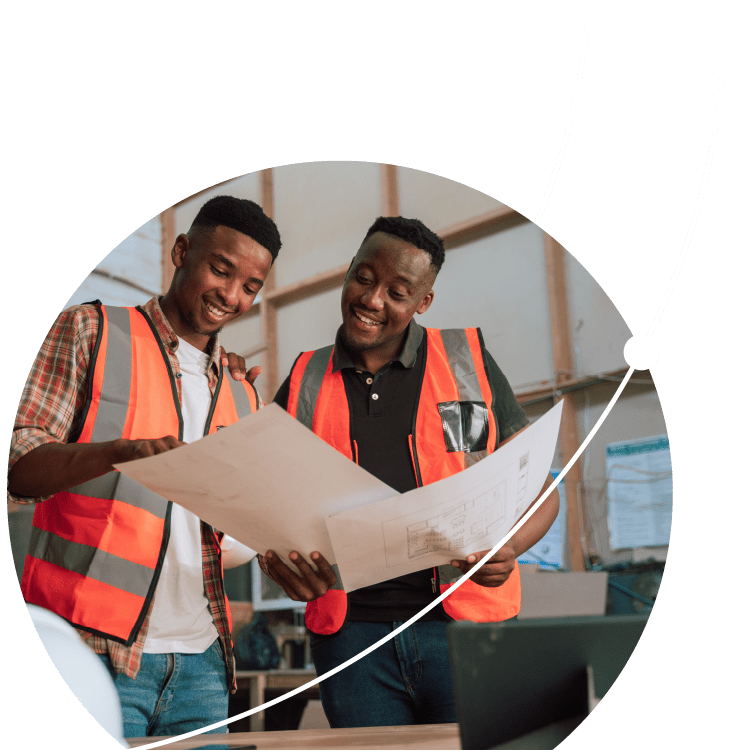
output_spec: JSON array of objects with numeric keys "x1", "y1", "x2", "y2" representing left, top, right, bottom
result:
[{"x1": 91, "y1": 306, "x2": 132, "y2": 443}]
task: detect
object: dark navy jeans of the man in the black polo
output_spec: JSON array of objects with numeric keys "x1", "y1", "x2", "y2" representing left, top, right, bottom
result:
[{"x1": 311, "y1": 621, "x2": 456, "y2": 728}]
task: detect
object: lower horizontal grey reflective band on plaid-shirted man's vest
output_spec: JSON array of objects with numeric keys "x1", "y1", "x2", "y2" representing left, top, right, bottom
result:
[{"x1": 29, "y1": 527, "x2": 154, "y2": 598}]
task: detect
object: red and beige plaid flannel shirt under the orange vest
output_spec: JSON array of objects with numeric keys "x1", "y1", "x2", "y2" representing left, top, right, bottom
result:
[{"x1": 7, "y1": 298, "x2": 236, "y2": 691}]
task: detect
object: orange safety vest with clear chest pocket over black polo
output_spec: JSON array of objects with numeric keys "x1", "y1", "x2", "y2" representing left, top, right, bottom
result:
[{"x1": 287, "y1": 329, "x2": 521, "y2": 634}]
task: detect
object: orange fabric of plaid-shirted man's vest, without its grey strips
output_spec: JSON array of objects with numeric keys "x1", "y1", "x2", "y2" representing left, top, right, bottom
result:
[{"x1": 22, "y1": 308, "x2": 258, "y2": 641}]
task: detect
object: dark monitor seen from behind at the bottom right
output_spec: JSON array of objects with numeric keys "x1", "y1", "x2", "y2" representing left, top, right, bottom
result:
[{"x1": 448, "y1": 615, "x2": 647, "y2": 749}]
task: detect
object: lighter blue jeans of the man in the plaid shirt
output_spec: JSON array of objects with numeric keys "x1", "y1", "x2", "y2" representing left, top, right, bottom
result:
[{"x1": 99, "y1": 639, "x2": 229, "y2": 749}]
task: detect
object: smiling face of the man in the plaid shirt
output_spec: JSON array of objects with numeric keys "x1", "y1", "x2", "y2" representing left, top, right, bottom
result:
[{"x1": 161, "y1": 225, "x2": 272, "y2": 350}]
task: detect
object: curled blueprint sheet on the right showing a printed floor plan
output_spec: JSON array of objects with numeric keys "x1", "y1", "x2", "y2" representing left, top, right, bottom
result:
[{"x1": 326, "y1": 402, "x2": 563, "y2": 592}]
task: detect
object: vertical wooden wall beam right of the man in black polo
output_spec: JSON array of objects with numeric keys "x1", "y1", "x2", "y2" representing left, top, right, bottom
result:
[{"x1": 544, "y1": 233, "x2": 586, "y2": 572}]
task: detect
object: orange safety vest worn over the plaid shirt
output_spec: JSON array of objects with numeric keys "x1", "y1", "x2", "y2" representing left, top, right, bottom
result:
[{"x1": 21, "y1": 303, "x2": 259, "y2": 645}]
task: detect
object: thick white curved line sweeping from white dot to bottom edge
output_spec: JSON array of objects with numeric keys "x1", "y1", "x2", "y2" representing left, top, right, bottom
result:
[{"x1": 133, "y1": 368, "x2": 634, "y2": 749}]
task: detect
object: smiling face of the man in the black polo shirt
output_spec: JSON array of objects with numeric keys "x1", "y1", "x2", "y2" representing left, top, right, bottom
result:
[{"x1": 342, "y1": 232, "x2": 435, "y2": 373}]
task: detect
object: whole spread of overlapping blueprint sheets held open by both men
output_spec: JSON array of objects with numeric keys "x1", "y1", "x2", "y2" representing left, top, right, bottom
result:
[{"x1": 116, "y1": 403, "x2": 561, "y2": 591}]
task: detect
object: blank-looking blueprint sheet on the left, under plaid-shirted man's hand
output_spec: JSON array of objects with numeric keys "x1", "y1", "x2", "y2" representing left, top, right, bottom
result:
[{"x1": 115, "y1": 404, "x2": 396, "y2": 569}]
